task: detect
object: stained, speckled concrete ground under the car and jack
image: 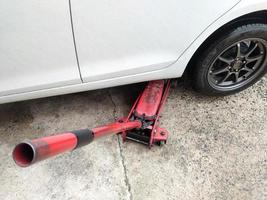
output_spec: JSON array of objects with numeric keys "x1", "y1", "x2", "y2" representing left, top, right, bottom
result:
[{"x1": 0, "y1": 77, "x2": 267, "y2": 200}]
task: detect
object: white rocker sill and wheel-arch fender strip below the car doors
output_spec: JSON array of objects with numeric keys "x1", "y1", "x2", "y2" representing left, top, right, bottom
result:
[{"x1": 0, "y1": 0, "x2": 267, "y2": 103}]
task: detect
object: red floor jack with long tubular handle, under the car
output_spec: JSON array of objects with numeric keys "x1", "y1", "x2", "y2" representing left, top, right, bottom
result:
[{"x1": 12, "y1": 80, "x2": 171, "y2": 167}]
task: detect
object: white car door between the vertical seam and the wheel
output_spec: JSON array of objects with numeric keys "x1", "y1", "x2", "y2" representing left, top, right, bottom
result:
[{"x1": 71, "y1": 0, "x2": 239, "y2": 82}]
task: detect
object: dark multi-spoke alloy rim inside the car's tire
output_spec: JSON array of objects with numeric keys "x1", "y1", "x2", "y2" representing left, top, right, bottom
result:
[{"x1": 208, "y1": 38, "x2": 267, "y2": 90}]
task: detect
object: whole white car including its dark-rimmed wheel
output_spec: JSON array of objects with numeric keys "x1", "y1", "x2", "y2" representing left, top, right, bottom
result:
[{"x1": 0, "y1": 0, "x2": 267, "y2": 103}]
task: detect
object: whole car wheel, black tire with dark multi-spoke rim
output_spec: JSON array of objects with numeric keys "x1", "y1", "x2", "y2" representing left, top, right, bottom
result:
[{"x1": 192, "y1": 24, "x2": 267, "y2": 96}]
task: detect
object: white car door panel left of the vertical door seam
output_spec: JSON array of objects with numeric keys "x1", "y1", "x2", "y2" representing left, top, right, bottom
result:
[{"x1": 0, "y1": 0, "x2": 81, "y2": 96}]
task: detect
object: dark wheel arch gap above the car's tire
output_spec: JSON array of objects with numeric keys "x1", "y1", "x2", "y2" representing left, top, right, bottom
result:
[{"x1": 183, "y1": 9, "x2": 267, "y2": 81}]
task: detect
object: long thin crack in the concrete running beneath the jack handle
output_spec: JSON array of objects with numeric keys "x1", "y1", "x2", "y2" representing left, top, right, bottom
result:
[{"x1": 108, "y1": 90, "x2": 133, "y2": 200}]
